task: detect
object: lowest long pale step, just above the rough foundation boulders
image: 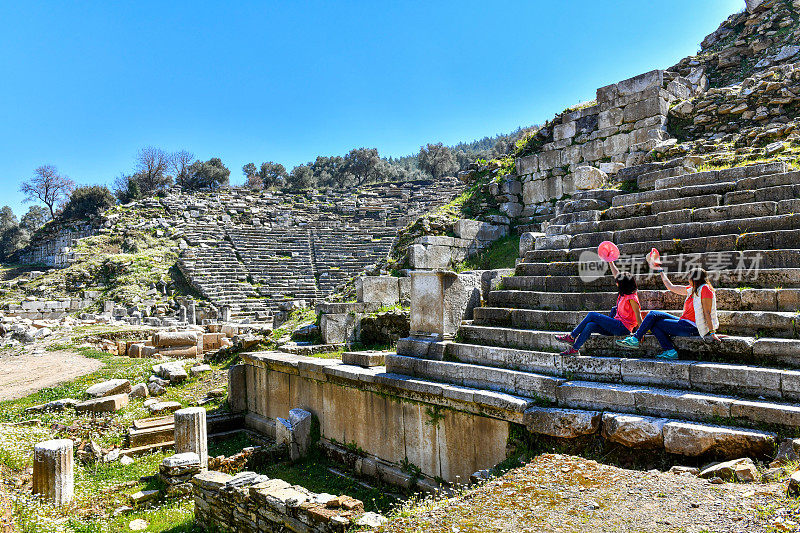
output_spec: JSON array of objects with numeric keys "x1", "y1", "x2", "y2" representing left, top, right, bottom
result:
[{"x1": 386, "y1": 354, "x2": 800, "y2": 429}]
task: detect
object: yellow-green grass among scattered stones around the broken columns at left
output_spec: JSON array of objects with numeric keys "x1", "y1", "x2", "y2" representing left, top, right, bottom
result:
[{"x1": 0, "y1": 326, "x2": 236, "y2": 533}]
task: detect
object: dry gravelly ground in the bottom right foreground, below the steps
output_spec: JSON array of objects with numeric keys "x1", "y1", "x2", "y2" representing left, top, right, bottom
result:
[{"x1": 380, "y1": 455, "x2": 798, "y2": 533}]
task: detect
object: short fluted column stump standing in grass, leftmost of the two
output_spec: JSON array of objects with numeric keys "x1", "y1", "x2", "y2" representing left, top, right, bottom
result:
[{"x1": 33, "y1": 439, "x2": 75, "y2": 505}]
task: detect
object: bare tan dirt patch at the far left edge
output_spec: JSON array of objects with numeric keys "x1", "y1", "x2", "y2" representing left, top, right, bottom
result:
[{"x1": 0, "y1": 350, "x2": 103, "y2": 400}]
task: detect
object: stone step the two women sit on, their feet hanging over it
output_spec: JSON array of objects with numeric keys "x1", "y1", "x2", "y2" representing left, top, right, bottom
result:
[{"x1": 459, "y1": 324, "x2": 800, "y2": 368}]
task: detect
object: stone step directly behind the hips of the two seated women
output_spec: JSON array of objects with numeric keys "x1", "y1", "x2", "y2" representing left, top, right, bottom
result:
[{"x1": 473, "y1": 307, "x2": 800, "y2": 339}]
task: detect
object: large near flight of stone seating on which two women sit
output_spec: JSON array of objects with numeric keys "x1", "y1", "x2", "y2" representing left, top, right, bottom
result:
[{"x1": 386, "y1": 163, "x2": 800, "y2": 456}]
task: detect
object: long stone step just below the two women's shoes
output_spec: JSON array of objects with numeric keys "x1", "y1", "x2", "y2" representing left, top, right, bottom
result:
[{"x1": 445, "y1": 343, "x2": 800, "y2": 402}]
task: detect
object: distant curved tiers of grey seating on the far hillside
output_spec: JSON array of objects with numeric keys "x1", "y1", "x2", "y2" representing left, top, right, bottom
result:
[{"x1": 171, "y1": 178, "x2": 465, "y2": 318}]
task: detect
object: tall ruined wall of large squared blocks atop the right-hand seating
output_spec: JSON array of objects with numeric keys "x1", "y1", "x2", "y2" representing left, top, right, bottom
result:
[{"x1": 492, "y1": 70, "x2": 691, "y2": 218}]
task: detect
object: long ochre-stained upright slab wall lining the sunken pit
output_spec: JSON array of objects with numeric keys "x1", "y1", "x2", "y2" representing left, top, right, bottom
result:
[{"x1": 238, "y1": 352, "x2": 512, "y2": 484}]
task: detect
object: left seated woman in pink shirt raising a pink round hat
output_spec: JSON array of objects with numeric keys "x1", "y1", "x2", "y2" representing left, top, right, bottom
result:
[{"x1": 556, "y1": 261, "x2": 642, "y2": 355}]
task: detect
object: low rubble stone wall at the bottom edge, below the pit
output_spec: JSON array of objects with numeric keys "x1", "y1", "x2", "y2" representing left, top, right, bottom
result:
[{"x1": 192, "y1": 471, "x2": 383, "y2": 533}]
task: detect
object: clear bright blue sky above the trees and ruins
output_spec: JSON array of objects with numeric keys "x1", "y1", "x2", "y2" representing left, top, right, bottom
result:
[{"x1": 0, "y1": 0, "x2": 744, "y2": 215}]
